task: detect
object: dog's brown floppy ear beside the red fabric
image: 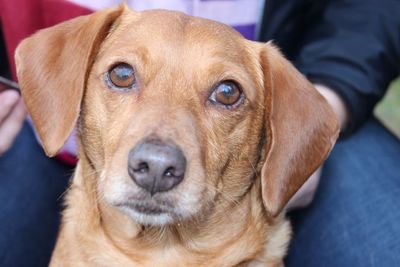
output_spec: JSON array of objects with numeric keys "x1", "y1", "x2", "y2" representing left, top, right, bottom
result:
[{"x1": 15, "y1": 7, "x2": 123, "y2": 156}]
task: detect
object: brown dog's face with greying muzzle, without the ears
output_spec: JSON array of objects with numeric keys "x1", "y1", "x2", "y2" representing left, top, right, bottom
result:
[{"x1": 81, "y1": 11, "x2": 264, "y2": 224}]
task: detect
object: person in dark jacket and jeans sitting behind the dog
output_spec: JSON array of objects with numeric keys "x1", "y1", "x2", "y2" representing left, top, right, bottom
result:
[{"x1": 0, "y1": 0, "x2": 400, "y2": 266}]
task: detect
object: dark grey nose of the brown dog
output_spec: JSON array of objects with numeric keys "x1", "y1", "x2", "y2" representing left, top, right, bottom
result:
[{"x1": 128, "y1": 139, "x2": 186, "y2": 195}]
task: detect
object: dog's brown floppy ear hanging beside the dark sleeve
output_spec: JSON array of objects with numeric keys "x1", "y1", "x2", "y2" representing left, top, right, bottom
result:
[{"x1": 261, "y1": 43, "x2": 339, "y2": 216}]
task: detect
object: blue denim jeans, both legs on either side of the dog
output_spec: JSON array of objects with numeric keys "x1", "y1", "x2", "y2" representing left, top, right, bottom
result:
[{"x1": 0, "y1": 119, "x2": 400, "y2": 267}]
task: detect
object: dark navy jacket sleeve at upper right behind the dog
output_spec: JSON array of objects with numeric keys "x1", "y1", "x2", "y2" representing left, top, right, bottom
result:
[{"x1": 295, "y1": 0, "x2": 400, "y2": 134}]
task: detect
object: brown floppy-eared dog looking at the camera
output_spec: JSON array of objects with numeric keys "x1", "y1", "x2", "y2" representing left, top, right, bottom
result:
[{"x1": 16, "y1": 7, "x2": 338, "y2": 266}]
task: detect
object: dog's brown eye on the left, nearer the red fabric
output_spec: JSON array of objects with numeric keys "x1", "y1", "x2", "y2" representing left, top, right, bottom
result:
[{"x1": 108, "y1": 63, "x2": 135, "y2": 88}]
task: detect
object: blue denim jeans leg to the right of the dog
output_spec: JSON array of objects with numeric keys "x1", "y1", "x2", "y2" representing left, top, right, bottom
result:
[{"x1": 286, "y1": 119, "x2": 400, "y2": 267}]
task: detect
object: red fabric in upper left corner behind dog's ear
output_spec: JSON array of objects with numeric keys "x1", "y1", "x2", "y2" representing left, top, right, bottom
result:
[{"x1": 0, "y1": 0, "x2": 92, "y2": 80}]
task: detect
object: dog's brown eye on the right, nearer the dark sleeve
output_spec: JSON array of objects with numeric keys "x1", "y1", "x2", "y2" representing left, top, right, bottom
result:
[{"x1": 209, "y1": 81, "x2": 242, "y2": 107}]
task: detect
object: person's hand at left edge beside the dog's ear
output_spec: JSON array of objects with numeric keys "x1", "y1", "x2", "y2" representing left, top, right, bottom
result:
[{"x1": 0, "y1": 90, "x2": 26, "y2": 156}]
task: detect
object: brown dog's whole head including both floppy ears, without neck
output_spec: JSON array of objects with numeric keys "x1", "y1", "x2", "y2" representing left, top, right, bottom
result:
[{"x1": 16, "y1": 7, "x2": 338, "y2": 225}]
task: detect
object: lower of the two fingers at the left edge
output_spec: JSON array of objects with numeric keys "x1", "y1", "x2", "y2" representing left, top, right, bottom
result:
[{"x1": 0, "y1": 100, "x2": 26, "y2": 155}]
